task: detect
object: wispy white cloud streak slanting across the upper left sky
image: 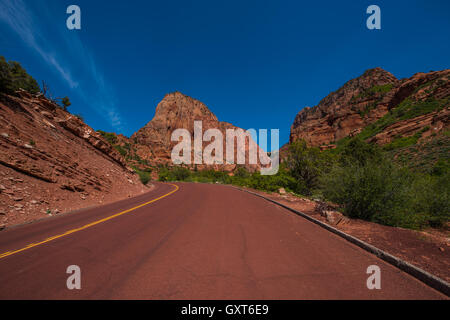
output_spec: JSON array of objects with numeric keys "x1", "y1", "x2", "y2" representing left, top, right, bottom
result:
[{"x1": 0, "y1": 0, "x2": 123, "y2": 130}]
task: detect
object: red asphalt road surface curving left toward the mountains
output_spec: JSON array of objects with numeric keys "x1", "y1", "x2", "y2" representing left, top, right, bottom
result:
[{"x1": 0, "y1": 183, "x2": 446, "y2": 299}]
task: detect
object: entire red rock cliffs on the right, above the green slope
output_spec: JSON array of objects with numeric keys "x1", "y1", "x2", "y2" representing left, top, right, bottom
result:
[{"x1": 290, "y1": 68, "x2": 450, "y2": 149}]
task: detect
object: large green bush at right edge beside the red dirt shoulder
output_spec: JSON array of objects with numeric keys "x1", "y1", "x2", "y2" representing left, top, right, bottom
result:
[{"x1": 321, "y1": 149, "x2": 450, "y2": 229}]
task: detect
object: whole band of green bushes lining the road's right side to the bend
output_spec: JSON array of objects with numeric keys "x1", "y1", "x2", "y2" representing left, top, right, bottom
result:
[{"x1": 159, "y1": 137, "x2": 450, "y2": 229}]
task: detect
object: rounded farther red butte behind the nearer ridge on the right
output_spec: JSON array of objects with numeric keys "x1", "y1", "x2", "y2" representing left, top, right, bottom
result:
[{"x1": 290, "y1": 68, "x2": 400, "y2": 146}]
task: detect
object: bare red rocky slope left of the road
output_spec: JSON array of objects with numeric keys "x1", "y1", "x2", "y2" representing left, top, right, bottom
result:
[{"x1": 0, "y1": 92, "x2": 146, "y2": 225}]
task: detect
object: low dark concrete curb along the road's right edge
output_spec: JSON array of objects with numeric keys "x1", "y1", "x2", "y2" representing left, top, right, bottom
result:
[{"x1": 232, "y1": 186, "x2": 450, "y2": 297}]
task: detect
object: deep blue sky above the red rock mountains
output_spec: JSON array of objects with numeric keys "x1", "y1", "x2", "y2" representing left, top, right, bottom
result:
[{"x1": 0, "y1": 0, "x2": 450, "y2": 148}]
